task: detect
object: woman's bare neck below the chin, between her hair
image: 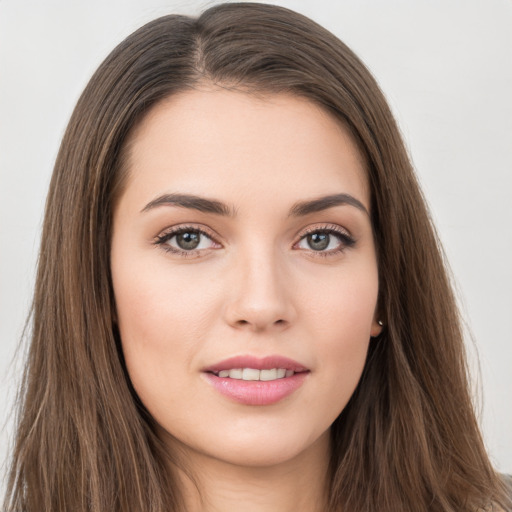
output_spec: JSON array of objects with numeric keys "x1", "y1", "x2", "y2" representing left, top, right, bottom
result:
[{"x1": 170, "y1": 432, "x2": 329, "y2": 512}]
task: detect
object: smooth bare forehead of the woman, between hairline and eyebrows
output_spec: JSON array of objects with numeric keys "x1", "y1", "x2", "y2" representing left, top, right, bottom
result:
[{"x1": 120, "y1": 88, "x2": 369, "y2": 210}]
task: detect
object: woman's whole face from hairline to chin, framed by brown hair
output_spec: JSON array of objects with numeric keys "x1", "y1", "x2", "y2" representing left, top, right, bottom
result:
[{"x1": 111, "y1": 89, "x2": 380, "y2": 466}]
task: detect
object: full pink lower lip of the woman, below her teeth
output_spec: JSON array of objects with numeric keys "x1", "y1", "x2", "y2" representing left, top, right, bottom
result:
[{"x1": 203, "y1": 372, "x2": 309, "y2": 405}]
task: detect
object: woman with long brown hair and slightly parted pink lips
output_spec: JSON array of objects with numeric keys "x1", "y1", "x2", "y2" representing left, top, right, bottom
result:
[{"x1": 5, "y1": 3, "x2": 510, "y2": 512}]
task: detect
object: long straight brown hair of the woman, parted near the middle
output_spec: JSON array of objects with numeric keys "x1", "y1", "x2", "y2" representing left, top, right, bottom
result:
[{"x1": 4, "y1": 3, "x2": 511, "y2": 512}]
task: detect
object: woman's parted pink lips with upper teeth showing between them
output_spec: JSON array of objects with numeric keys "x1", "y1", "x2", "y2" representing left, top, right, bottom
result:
[{"x1": 203, "y1": 356, "x2": 310, "y2": 405}]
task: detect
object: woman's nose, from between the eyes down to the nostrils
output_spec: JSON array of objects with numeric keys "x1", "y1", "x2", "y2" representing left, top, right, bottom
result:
[{"x1": 225, "y1": 247, "x2": 296, "y2": 332}]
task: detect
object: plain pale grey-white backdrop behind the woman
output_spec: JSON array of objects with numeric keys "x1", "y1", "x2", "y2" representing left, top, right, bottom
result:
[{"x1": 0, "y1": 0, "x2": 512, "y2": 495}]
